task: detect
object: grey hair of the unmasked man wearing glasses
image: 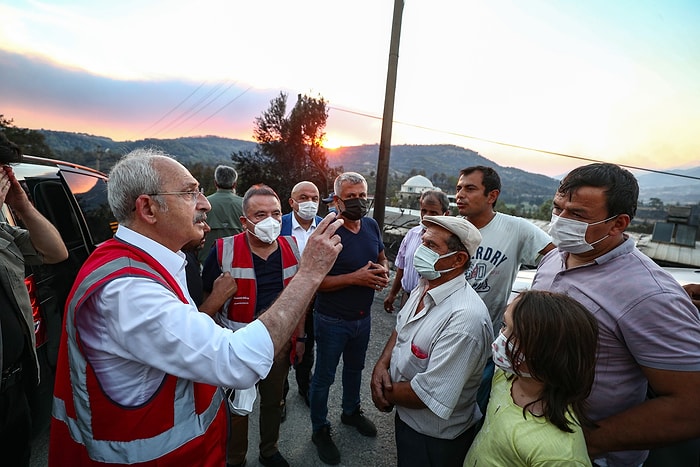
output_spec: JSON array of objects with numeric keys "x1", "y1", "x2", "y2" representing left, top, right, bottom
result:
[{"x1": 107, "y1": 148, "x2": 172, "y2": 227}]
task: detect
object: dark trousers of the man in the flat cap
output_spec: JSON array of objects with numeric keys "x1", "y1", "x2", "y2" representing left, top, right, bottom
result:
[{"x1": 394, "y1": 413, "x2": 476, "y2": 467}]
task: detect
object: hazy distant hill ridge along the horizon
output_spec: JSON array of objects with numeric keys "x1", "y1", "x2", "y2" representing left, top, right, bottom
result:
[{"x1": 40, "y1": 130, "x2": 700, "y2": 204}]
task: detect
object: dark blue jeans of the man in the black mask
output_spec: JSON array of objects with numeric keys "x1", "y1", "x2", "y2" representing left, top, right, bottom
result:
[{"x1": 309, "y1": 312, "x2": 372, "y2": 432}]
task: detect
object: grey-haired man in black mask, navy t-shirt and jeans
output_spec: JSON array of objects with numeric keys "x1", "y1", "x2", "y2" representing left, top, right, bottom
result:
[{"x1": 309, "y1": 172, "x2": 389, "y2": 465}]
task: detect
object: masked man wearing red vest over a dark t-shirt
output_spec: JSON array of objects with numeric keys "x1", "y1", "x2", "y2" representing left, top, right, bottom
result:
[{"x1": 202, "y1": 185, "x2": 304, "y2": 467}]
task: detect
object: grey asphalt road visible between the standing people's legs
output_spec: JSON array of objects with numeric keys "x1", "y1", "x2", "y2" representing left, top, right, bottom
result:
[{"x1": 30, "y1": 288, "x2": 396, "y2": 467}]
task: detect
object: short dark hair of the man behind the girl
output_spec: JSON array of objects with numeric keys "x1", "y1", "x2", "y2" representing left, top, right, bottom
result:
[{"x1": 557, "y1": 163, "x2": 639, "y2": 220}]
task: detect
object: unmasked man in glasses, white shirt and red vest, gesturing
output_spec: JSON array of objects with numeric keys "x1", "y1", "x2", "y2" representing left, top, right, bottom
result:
[{"x1": 49, "y1": 150, "x2": 342, "y2": 466}]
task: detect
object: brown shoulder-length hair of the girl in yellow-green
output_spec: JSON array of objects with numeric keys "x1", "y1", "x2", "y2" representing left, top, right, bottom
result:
[{"x1": 506, "y1": 290, "x2": 598, "y2": 433}]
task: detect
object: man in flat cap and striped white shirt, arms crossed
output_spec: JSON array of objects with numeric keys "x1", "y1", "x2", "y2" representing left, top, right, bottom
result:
[{"x1": 371, "y1": 216, "x2": 493, "y2": 467}]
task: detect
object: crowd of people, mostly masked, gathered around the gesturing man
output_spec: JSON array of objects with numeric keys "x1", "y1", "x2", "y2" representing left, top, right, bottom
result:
[{"x1": 0, "y1": 134, "x2": 700, "y2": 467}]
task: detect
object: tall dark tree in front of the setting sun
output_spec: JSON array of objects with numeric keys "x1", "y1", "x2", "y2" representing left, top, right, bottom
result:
[{"x1": 231, "y1": 92, "x2": 338, "y2": 211}]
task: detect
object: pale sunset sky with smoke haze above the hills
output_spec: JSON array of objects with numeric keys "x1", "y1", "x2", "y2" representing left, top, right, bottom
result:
[{"x1": 0, "y1": 0, "x2": 700, "y2": 175}]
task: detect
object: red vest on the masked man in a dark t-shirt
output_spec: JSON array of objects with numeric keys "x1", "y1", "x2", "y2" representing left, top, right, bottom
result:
[{"x1": 216, "y1": 232, "x2": 299, "y2": 331}]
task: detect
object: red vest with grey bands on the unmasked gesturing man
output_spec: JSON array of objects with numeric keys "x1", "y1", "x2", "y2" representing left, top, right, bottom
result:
[{"x1": 49, "y1": 240, "x2": 227, "y2": 467}]
